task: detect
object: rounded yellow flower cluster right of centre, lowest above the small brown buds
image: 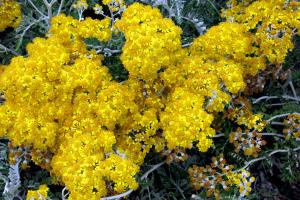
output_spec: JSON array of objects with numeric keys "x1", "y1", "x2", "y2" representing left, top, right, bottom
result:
[{"x1": 160, "y1": 88, "x2": 215, "y2": 152}]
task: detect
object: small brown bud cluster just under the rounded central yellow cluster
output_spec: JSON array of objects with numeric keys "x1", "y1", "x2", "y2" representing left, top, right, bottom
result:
[{"x1": 161, "y1": 147, "x2": 188, "y2": 164}]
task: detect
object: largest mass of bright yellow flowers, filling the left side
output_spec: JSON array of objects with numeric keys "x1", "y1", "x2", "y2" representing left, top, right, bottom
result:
[{"x1": 0, "y1": 15, "x2": 139, "y2": 199}]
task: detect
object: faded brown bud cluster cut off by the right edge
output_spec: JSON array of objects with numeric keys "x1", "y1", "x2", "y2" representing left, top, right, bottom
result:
[{"x1": 283, "y1": 114, "x2": 300, "y2": 140}]
